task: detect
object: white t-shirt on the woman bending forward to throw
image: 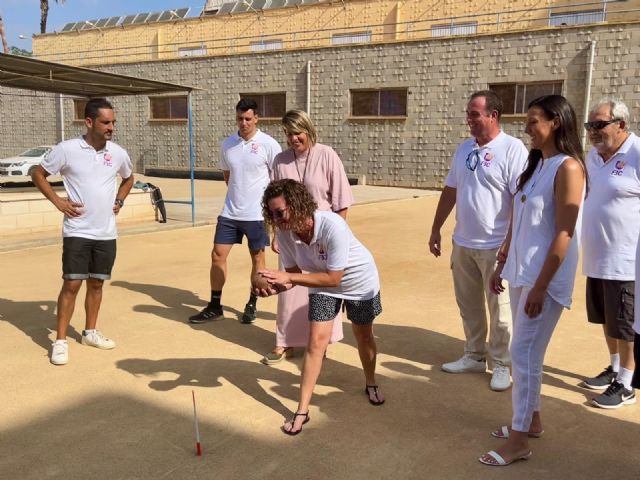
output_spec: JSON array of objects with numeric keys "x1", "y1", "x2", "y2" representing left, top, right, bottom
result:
[{"x1": 277, "y1": 210, "x2": 380, "y2": 300}]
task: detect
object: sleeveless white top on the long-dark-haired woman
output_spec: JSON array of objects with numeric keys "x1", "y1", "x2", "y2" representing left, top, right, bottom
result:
[{"x1": 502, "y1": 153, "x2": 582, "y2": 308}]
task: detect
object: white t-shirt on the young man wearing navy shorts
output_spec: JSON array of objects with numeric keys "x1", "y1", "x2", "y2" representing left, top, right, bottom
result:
[{"x1": 219, "y1": 130, "x2": 282, "y2": 221}]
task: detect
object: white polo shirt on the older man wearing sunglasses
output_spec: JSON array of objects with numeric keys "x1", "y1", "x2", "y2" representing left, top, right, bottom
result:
[{"x1": 582, "y1": 133, "x2": 640, "y2": 281}]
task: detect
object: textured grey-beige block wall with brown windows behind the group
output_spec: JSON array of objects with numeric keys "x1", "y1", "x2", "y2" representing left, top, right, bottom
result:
[{"x1": 5, "y1": 23, "x2": 640, "y2": 188}]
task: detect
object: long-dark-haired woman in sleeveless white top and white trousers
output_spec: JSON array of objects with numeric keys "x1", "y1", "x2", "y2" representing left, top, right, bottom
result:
[{"x1": 479, "y1": 95, "x2": 587, "y2": 466}]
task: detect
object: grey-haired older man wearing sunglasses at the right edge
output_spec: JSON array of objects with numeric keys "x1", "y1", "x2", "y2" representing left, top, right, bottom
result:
[{"x1": 582, "y1": 98, "x2": 640, "y2": 409}]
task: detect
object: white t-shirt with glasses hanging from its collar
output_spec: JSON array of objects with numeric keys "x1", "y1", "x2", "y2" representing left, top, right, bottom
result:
[{"x1": 445, "y1": 131, "x2": 528, "y2": 250}]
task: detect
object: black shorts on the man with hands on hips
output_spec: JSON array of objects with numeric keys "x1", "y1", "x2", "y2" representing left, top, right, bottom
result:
[{"x1": 62, "y1": 237, "x2": 116, "y2": 280}]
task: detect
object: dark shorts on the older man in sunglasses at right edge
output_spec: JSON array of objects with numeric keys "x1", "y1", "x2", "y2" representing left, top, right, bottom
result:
[{"x1": 586, "y1": 277, "x2": 635, "y2": 342}]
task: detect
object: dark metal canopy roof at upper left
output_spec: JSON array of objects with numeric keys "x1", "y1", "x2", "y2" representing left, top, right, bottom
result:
[{"x1": 0, "y1": 53, "x2": 194, "y2": 97}]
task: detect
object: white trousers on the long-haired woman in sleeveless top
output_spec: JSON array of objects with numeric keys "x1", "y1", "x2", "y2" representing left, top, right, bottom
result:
[{"x1": 509, "y1": 287, "x2": 563, "y2": 432}]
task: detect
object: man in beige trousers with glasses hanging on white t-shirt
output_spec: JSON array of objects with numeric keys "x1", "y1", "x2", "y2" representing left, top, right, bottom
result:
[{"x1": 429, "y1": 90, "x2": 527, "y2": 391}]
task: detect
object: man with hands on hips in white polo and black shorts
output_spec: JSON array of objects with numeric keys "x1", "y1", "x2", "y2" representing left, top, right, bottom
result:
[{"x1": 32, "y1": 98, "x2": 133, "y2": 365}]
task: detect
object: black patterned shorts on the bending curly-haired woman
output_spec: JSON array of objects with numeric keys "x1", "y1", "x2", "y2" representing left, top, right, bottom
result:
[{"x1": 309, "y1": 292, "x2": 382, "y2": 325}]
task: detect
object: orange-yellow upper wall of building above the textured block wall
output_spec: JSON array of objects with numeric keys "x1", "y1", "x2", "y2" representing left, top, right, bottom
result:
[{"x1": 33, "y1": 0, "x2": 640, "y2": 66}]
